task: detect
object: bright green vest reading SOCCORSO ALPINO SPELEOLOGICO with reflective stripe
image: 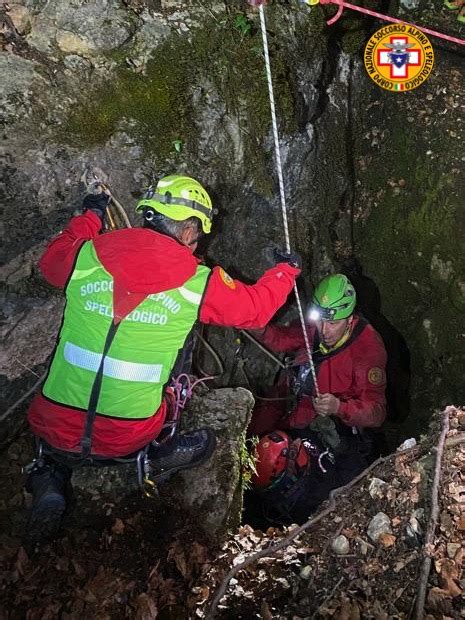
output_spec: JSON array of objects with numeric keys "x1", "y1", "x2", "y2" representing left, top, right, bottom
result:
[{"x1": 43, "y1": 241, "x2": 210, "y2": 419}]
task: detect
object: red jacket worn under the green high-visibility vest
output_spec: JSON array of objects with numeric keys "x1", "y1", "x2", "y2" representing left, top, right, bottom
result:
[{"x1": 28, "y1": 211, "x2": 299, "y2": 456}]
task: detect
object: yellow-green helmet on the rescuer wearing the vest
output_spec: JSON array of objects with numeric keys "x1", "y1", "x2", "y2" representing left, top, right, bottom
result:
[{"x1": 136, "y1": 174, "x2": 213, "y2": 234}]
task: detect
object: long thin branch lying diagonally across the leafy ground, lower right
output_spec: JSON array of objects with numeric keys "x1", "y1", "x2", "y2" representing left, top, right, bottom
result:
[{"x1": 205, "y1": 446, "x2": 418, "y2": 620}]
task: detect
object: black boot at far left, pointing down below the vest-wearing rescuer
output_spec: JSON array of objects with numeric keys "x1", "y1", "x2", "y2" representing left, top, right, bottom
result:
[{"x1": 25, "y1": 461, "x2": 71, "y2": 544}]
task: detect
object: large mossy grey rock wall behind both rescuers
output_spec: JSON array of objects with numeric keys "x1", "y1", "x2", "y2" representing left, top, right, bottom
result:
[{"x1": 0, "y1": 0, "x2": 465, "y2": 446}]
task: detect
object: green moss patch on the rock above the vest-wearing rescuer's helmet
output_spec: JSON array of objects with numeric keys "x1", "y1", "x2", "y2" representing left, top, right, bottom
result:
[{"x1": 62, "y1": 10, "x2": 296, "y2": 184}]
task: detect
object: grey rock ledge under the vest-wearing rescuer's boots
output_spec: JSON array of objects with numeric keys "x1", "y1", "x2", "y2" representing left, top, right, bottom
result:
[{"x1": 73, "y1": 388, "x2": 254, "y2": 541}]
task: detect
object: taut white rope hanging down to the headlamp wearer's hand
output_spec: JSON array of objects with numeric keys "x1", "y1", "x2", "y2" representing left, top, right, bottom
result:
[{"x1": 259, "y1": 4, "x2": 320, "y2": 397}]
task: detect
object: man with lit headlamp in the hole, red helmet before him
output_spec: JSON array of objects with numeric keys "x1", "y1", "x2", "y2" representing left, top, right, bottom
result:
[{"x1": 249, "y1": 274, "x2": 386, "y2": 521}]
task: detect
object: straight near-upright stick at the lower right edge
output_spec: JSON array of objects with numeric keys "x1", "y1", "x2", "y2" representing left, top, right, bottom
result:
[{"x1": 414, "y1": 407, "x2": 455, "y2": 620}]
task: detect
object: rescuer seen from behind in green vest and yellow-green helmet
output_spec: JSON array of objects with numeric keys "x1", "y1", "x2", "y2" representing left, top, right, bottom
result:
[{"x1": 27, "y1": 175, "x2": 300, "y2": 541}]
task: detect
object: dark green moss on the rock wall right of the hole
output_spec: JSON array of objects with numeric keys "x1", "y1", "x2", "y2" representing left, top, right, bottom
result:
[{"x1": 356, "y1": 127, "x2": 465, "y2": 407}]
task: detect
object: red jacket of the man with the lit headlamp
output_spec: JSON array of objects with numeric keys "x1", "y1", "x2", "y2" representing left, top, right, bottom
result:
[{"x1": 250, "y1": 316, "x2": 387, "y2": 435}]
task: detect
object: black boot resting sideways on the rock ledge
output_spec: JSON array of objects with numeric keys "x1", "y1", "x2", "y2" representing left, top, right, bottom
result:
[{"x1": 150, "y1": 428, "x2": 216, "y2": 479}]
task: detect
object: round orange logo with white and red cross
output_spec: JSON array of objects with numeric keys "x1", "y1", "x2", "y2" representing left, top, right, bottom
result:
[{"x1": 364, "y1": 24, "x2": 434, "y2": 92}]
